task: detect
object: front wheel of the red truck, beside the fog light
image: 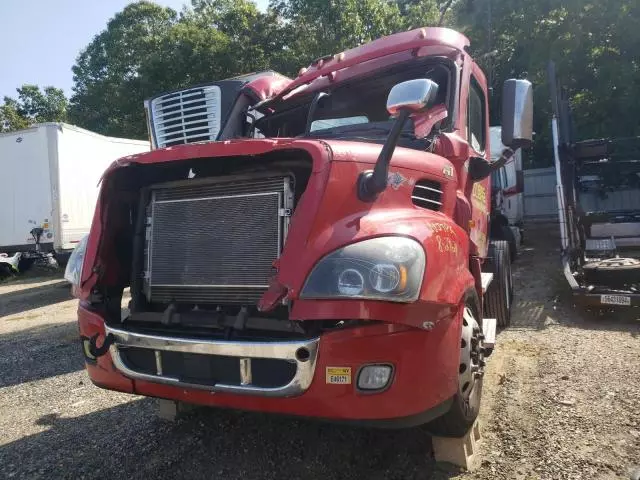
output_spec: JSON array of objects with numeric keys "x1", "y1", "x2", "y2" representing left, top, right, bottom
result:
[{"x1": 426, "y1": 292, "x2": 484, "y2": 437}]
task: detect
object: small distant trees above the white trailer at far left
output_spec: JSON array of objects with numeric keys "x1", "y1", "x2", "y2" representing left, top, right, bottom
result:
[{"x1": 0, "y1": 85, "x2": 68, "y2": 132}]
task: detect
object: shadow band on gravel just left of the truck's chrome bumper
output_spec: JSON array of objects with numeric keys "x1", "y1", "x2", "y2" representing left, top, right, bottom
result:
[{"x1": 0, "y1": 322, "x2": 84, "y2": 388}]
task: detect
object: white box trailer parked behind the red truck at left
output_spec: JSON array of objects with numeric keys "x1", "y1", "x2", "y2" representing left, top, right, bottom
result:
[{"x1": 0, "y1": 123, "x2": 150, "y2": 258}]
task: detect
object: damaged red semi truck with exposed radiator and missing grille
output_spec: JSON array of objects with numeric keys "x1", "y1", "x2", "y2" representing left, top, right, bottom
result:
[{"x1": 68, "y1": 28, "x2": 532, "y2": 436}]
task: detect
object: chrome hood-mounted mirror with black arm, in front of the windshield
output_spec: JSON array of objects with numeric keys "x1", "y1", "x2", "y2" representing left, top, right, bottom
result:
[{"x1": 356, "y1": 78, "x2": 438, "y2": 202}]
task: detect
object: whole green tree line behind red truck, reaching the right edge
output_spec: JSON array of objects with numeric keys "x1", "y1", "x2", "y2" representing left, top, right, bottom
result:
[{"x1": 55, "y1": 0, "x2": 640, "y2": 166}]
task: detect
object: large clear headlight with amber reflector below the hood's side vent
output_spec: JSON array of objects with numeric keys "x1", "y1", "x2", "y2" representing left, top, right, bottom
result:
[{"x1": 300, "y1": 237, "x2": 425, "y2": 302}]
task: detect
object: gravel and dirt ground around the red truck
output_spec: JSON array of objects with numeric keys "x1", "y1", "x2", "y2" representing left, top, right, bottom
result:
[{"x1": 0, "y1": 226, "x2": 640, "y2": 480}]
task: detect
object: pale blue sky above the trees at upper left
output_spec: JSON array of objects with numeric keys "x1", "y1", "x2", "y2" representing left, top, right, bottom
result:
[{"x1": 0, "y1": 0, "x2": 268, "y2": 99}]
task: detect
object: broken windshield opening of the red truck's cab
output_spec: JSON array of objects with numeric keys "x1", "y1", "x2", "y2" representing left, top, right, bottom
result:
[{"x1": 256, "y1": 58, "x2": 455, "y2": 148}]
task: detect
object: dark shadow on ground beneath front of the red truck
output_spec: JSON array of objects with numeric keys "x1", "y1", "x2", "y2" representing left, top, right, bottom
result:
[{"x1": 0, "y1": 399, "x2": 459, "y2": 480}]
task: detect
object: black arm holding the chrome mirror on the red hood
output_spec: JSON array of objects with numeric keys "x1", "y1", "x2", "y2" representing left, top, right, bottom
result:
[{"x1": 357, "y1": 109, "x2": 411, "y2": 202}]
